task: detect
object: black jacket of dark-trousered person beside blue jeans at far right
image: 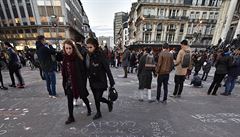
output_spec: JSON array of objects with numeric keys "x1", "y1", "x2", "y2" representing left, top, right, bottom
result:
[{"x1": 215, "y1": 55, "x2": 232, "y2": 74}]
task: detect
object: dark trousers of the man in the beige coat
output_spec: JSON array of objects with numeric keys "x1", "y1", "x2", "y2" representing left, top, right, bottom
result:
[{"x1": 173, "y1": 75, "x2": 185, "y2": 96}]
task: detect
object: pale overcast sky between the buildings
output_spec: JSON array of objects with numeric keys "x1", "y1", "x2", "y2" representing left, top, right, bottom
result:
[{"x1": 81, "y1": 0, "x2": 137, "y2": 37}]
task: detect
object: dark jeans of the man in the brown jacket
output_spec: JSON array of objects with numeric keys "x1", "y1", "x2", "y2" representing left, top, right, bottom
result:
[{"x1": 157, "y1": 74, "x2": 169, "y2": 101}]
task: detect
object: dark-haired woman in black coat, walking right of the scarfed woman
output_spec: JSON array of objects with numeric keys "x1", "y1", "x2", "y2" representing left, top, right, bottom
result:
[{"x1": 87, "y1": 38, "x2": 115, "y2": 120}]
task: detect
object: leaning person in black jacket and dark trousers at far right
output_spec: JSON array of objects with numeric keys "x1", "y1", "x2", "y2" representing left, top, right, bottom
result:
[{"x1": 207, "y1": 48, "x2": 232, "y2": 96}]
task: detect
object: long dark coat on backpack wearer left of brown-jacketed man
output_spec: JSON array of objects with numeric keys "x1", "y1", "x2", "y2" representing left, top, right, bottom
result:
[{"x1": 137, "y1": 54, "x2": 153, "y2": 89}]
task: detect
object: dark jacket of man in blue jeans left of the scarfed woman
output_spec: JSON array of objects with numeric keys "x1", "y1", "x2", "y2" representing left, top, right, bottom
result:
[{"x1": 36, "y1": 44, "x2": 56, "y2": 72}]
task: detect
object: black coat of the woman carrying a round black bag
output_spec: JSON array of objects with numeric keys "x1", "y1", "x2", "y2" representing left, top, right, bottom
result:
[{"x1": 89, "y1": 51, "x2": 115, "y2": 90}]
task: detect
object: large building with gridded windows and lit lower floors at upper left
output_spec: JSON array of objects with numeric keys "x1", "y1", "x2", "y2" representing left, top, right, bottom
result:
[{"x1": 0, "y1": 0, "x2": 90, "y2": 48}]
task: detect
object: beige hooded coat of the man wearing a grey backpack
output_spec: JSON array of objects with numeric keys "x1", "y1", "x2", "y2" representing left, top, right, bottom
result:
[{"x1": 175, "y1": 46, "x2": 191, "y2": 76}]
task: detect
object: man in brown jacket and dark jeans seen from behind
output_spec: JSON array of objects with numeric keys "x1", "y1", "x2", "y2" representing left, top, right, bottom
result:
[{"x1": 156, "y1": 43, "x2": 174, "y2": 104}]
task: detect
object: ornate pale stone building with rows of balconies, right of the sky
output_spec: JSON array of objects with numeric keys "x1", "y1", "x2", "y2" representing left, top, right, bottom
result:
[{"x1": 129, "y1": 0, "x2": 222, "y2": 45}]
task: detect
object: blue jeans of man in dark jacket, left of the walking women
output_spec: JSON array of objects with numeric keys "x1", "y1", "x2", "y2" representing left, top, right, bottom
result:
[{"x1": 44, "y1": 71, "x2": 56, "y2": 96}]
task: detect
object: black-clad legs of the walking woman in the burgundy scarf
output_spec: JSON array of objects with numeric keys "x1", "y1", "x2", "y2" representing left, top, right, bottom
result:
[{"x1": 67, "y1": 91, "x2": 91, "y2": 118}]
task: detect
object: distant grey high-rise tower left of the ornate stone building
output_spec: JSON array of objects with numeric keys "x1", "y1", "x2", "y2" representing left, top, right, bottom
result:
[{"x1": 113, "y1": 12, "x2": 128, "y2": 45}]
